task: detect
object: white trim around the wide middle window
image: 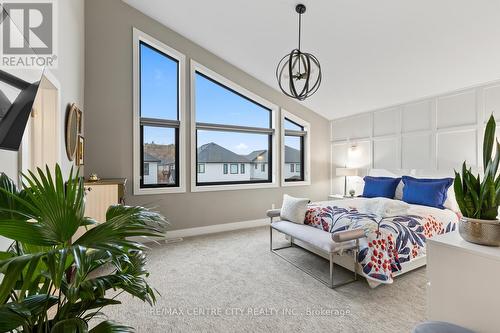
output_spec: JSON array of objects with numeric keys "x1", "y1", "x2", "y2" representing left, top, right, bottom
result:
[{"x1": 190, "y1": 59, "x2": 279, "y2": 192}]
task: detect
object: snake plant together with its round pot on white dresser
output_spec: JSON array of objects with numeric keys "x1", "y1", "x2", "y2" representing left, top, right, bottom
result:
[{"x1": 454, "y1": 115, "x2": 500, "y2": 246}]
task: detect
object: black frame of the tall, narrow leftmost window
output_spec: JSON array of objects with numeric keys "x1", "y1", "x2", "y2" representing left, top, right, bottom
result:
[{"x1": 138, "y1": 40, "x2": 180, "y2": 189}]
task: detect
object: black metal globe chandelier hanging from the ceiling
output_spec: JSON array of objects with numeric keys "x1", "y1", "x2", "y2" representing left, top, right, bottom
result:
[{"x1": 276, "y1": 4, "x2": 321, "y2": 101}]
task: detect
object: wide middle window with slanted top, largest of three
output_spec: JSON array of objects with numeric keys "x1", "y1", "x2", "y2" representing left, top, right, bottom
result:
[{"x1": 191, "y1": 63, "x2": 275, "y2": 191}]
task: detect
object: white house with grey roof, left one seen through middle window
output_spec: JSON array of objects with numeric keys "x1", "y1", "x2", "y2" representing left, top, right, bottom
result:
[{"x1": 197, "y1": 142, "x2": 250, "y2": 183}]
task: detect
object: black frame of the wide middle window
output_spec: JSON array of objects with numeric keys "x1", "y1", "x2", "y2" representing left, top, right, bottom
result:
[{"x1": 191, "y1": 69, "x2": 275, "y2": 187}]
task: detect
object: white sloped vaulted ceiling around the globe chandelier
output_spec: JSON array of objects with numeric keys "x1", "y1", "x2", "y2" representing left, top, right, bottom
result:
[{"x1": 124, "y1": 0, "x2": 500, "y2": 119}]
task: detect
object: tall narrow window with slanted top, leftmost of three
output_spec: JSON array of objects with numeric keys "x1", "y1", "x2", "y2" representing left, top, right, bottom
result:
[{"x1": 133, "y1": 29, "x2": 185, "y2": 194}]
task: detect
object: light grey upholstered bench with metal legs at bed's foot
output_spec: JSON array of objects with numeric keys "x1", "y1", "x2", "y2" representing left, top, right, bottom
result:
[{"x1": 267, "y1": 209, "x2": 365, "y2": 288}]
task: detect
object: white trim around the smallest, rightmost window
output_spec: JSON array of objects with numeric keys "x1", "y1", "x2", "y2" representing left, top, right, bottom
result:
[{"x1": 281, "y1": 109, "x2": 311, "y2": 187}]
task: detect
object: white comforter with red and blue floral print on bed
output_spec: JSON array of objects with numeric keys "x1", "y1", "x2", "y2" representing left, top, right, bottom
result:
[{"x1": 304, "y1": 198, "x2": 458, "y2": 283}]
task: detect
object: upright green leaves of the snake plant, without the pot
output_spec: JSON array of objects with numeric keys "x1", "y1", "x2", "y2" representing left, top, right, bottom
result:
[{"x1": 454, "y1": 115, "x2": 500, "y2": 220}]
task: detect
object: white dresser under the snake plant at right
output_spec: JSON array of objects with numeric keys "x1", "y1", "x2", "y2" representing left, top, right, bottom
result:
[{"x1": 427, "y1": 231, "x2": 500, "y2": 333}]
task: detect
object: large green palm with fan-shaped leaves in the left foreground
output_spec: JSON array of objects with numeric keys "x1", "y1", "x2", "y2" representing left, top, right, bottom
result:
[{"x1": 0, "y1": 166, "x2": 166, "y2": 333}]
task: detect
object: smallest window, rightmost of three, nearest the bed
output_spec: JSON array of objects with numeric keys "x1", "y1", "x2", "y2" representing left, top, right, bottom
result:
[{"x1": 282, "y1": 110, "x2": 310, "y2": 186}]
